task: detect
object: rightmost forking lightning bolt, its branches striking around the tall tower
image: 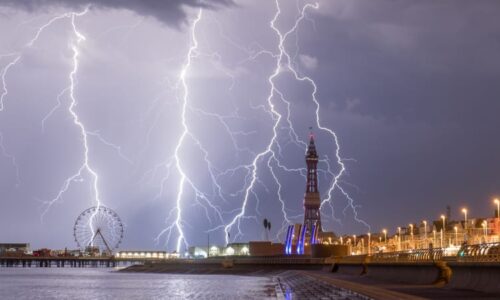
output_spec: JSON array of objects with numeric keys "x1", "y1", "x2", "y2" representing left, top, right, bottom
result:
[{"x1": 224, "y1": 0, "x2": 370, "y2": 243}]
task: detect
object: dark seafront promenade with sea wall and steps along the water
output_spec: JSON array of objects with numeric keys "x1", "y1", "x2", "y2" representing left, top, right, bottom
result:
[{"x1": 124, "y1": 244, "x2": 500, "y2": 300}]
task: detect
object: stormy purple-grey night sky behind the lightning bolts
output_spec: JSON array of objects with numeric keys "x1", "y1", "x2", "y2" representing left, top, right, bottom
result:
[{"x1": 0, "y1": 0, "x2": 500, "y2": 250}]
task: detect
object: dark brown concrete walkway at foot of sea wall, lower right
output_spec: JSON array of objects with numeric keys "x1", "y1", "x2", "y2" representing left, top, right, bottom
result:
[{"x1": 298, "y1": 271, "x2": 500, "y2": 300}]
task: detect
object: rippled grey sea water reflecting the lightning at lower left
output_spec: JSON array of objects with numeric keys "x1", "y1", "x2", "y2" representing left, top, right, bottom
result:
[{"x1": 0, "y1": 268, "x2": 276, "y2": 300}]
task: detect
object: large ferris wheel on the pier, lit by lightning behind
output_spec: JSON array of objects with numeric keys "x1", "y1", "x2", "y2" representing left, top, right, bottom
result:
[{"x1": 73, "y1": 205, "x2": 123, "y2": 253}]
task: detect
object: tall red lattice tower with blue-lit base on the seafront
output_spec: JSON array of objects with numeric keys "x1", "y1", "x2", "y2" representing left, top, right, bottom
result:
[{"x1": 285, "y1": 133, "x2": 333, "y2": 254}]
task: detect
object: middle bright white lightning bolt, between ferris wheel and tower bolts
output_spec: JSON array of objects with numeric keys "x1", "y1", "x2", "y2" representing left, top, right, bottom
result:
[{"x1": 150, "y1": 9, "x2": 253, "y2": 252}]
